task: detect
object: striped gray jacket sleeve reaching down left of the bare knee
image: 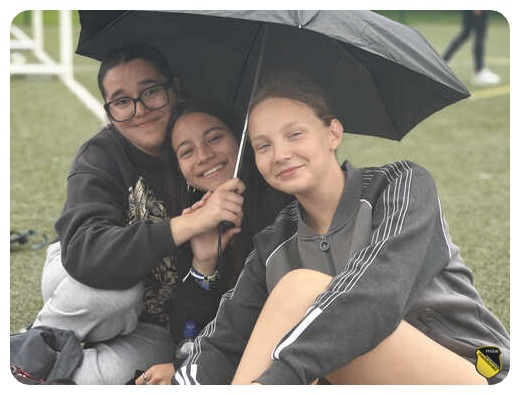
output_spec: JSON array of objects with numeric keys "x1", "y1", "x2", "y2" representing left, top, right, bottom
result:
[{"x1": 172, "y1": 251, "x2": 267, "y2": 385}]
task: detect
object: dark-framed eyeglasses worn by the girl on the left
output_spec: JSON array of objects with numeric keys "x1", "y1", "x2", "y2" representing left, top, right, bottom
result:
[{"x1": 103, "y1": 82, "x2": 170, "y2": 122}]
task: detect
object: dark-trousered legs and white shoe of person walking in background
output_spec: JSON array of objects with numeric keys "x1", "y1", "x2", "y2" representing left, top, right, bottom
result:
[{"x1": 443, "y1": 10, "x2": 501, "y2": 86}]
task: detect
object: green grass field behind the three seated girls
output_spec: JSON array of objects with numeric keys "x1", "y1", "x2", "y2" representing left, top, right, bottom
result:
[{"x1": 10, "y1": 13, "x2": 510, "y2": 338}]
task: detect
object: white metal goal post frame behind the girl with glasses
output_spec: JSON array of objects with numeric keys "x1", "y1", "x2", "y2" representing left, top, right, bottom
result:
[{"x1": 10, "y1": 10, "x2": 106, "y2": 121}]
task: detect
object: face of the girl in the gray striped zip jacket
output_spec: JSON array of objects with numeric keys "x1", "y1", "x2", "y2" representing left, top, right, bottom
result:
[{"x1": 249, "y1": 97, "x2": 343, "y2": 197}]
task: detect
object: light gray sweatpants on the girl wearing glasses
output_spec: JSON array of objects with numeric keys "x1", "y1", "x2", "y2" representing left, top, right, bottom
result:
[{"x1": 33, "y1": 242, "x2": 174, "y2": 384}]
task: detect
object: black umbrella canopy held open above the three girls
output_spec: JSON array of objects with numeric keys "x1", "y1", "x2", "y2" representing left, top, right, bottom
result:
[{"x1": 76, "y1": 11, "x2": 469, "y2": 140}]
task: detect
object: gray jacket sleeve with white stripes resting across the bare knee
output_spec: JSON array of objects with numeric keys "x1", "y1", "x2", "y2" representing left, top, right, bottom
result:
[{"x1": 257, "y1": 162, "x2": 449, "y2": 384}]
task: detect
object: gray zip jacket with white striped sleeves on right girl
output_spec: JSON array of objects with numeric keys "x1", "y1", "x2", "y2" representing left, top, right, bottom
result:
[{"x1": 173, "y1": 162, "x2": 509, "y2": 384}]
